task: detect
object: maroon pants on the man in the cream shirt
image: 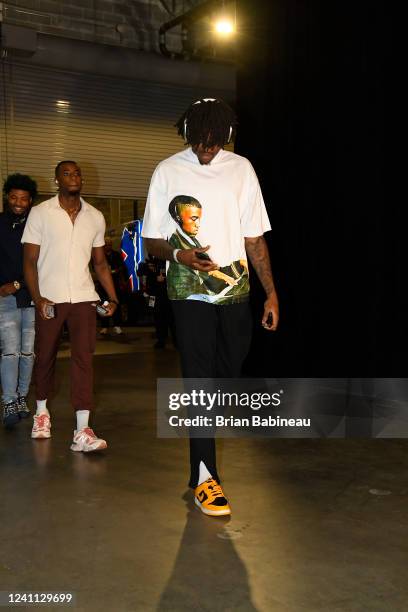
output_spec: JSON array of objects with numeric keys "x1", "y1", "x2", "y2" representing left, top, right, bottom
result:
[{"x1": 34, "y1": 302, "x2": 96, "y2": 410}]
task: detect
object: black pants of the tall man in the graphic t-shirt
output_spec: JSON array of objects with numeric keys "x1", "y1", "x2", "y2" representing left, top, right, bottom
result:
[{"x1": 172, "y1": 300, "x2": 252, "y2": 488}]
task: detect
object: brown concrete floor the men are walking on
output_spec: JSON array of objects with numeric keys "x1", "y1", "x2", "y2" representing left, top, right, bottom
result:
[{"x1": 0, "y1": 329, "x2": 408, "y2": 612}]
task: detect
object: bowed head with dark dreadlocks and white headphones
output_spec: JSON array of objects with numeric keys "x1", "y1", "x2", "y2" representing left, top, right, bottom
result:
[{"x1": 176, "y1": 99, "x2": 237, "y2": 147}]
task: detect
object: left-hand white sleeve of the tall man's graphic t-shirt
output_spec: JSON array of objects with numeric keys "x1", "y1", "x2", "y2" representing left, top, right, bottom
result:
[{"x1": 142, "y1": 165, "x2": 169, "y2": 240}]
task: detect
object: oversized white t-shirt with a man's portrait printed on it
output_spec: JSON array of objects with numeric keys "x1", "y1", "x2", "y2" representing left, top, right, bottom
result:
[{"x1": 142, "y1": 148, "x2": 271, "y2": 304}]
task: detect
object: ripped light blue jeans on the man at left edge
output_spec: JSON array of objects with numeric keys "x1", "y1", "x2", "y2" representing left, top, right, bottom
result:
[{"x1": 0, "y1": 295, "x2": 35, "y2": 403}]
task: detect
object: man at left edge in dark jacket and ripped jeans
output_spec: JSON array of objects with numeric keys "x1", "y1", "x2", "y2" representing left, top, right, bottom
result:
[{"x1": 0, "y1": 174, "x2": 37, "y2": 427}]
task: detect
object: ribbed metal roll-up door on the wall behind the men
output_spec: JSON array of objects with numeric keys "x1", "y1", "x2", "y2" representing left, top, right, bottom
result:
[{"x1": 0, "y1": 64, "x2": 234, "y2": 198}]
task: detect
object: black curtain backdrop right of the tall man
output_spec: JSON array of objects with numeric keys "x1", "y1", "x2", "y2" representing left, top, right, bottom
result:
[{"x1": 236, "y1": 0, "x2": 400, "y2": 376}]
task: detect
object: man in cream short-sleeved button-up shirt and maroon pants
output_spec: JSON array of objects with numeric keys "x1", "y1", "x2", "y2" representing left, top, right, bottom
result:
[{"x1": 22, "y1": 161, "x2": 118, "y2": 452}]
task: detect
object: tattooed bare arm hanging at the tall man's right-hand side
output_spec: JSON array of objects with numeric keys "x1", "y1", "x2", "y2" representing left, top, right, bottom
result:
[{"x1": 245, "y1": 236, "x2": 279, "y2": 331}]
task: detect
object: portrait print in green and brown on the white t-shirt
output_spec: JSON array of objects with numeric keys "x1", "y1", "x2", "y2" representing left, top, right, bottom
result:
[{"x1": 167, "y1": 195, "x2": 249, "y2": 304}]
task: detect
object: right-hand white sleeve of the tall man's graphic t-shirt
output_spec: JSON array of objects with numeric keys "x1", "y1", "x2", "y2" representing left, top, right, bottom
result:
[{"x1": 241, "y1": 162, "x2": 271, "y2": 238}]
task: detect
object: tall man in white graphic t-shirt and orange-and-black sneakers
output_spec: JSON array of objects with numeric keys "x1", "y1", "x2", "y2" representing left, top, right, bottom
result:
[{"x1": 143, "y1": 98, "x2": 279, "y2": 516}]
